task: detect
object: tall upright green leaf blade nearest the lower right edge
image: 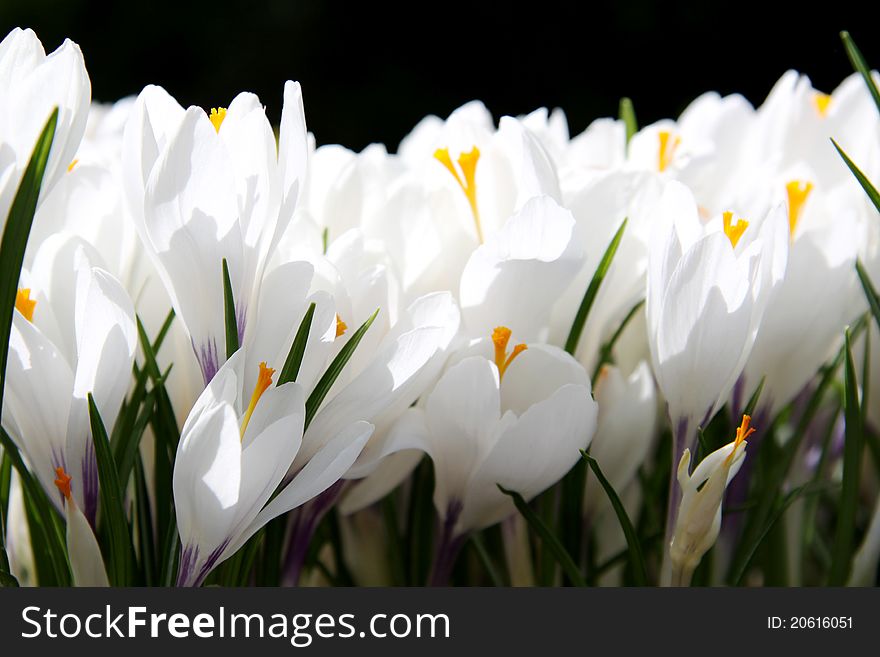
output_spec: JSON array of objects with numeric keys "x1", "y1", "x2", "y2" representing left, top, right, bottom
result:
[{"x1": 828, "y1": 329, "x2": 865, "y2": 586}]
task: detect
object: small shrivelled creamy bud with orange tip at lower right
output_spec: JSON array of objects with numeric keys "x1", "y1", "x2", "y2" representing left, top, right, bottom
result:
[{"x1": 662, "y1": 415, "x2": 755, "y2": 586}]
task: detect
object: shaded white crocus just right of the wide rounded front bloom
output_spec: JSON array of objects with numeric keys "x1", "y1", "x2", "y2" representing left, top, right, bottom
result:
[{"x1": 584, "y1": 361, "x2": 657, "y2": 516}]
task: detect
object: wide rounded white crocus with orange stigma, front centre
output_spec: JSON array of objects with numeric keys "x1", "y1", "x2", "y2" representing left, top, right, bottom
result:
[{"x1": 360, "y1": 327, "x2": 597, "y2": 560}]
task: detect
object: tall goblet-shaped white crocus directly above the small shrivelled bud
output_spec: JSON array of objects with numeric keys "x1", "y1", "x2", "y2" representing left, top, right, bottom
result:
[{"x1": 646, "y1": 182, "x2": 788, "y2": 444}]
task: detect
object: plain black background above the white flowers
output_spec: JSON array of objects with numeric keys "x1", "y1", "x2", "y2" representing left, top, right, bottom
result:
[{"x1": 0, "y1": 0, "x2": 880, "y2": 149}]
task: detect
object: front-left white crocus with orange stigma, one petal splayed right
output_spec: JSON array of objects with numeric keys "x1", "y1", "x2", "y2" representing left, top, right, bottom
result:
[{"x1": 174, "y1": 348, "x2": 373, "y2": 586}]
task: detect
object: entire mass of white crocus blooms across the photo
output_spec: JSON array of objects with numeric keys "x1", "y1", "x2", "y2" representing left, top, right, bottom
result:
[{"x1": 0, "y1": 29, "x2": 880, "y2": 585}]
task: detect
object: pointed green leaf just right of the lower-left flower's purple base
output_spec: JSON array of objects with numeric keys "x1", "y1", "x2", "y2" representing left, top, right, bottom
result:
[{"x1": 88, "y1": 393, "x2": 134, "y2": 586}]
